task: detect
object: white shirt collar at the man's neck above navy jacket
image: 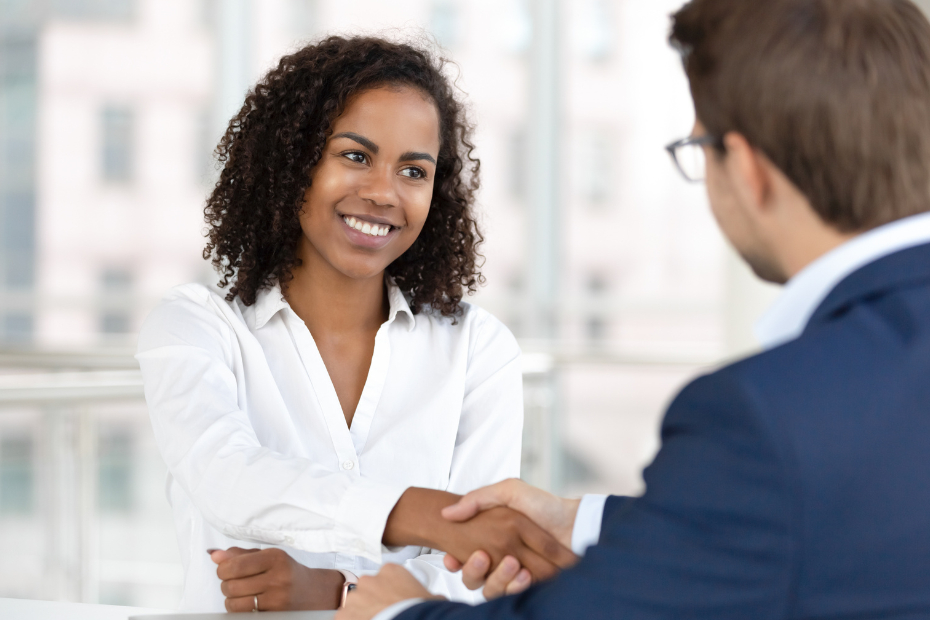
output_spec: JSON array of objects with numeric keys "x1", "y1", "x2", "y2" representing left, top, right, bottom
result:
[{"x1": 754, "y1": 213, "x2": 930, "y2": 349}]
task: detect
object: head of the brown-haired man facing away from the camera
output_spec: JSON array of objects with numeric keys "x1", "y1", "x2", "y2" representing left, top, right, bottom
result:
[{"x1": 670, "y1": 0, "x2": 930, "y2": 281}]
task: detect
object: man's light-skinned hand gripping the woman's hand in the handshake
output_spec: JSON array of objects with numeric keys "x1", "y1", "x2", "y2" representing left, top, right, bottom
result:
[{"x1": 442, "y1": 479, "x2": 580, "y2": 600}]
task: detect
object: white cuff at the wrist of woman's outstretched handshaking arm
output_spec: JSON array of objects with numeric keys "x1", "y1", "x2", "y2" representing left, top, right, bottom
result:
[{"x1": 334, "y1": 478, "x2": 407, "y2": 563}]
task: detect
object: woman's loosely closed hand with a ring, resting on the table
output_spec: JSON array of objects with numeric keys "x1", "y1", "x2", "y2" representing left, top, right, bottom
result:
[{"x1": 210, "y1": 547, "x2": 345, "y2": 612}]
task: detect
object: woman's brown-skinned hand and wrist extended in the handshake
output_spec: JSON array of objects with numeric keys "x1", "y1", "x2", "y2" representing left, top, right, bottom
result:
[{"x1": 383, "y1": 488, "x2": 577, "y2": 580}]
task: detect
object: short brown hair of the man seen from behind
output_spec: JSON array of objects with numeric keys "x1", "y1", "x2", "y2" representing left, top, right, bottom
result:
[{"x1": 670, "y1": 0, "x2": 930, "y2": 232}]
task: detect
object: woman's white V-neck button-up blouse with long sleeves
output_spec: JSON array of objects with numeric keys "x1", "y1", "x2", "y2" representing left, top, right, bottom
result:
[{"x1": 136, "y1": 283, "x2": 523, "y2": 611}]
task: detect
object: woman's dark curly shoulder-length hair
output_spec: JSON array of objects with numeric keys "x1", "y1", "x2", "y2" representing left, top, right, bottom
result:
[{"x1": 203, "y1": 36, "x2": 484, "y2": 320}]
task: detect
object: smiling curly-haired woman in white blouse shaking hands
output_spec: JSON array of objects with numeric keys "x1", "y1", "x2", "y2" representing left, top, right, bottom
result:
[{"x1": 137, "y1": 37, "x2": 570, "y2": 611}]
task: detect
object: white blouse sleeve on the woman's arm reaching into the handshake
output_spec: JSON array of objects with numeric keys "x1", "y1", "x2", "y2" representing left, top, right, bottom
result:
[{"x1": 136, "y1": 287, "x2": 404, "y2": 562}]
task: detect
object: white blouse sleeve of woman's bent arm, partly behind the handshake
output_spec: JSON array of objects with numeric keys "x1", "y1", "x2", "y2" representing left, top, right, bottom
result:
[{"x1": 405, "y1": 313, "x2": 523, "y2": 604}]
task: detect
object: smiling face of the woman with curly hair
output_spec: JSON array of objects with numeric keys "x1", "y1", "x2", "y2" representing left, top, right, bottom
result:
[{"x1": 300, "y1": 87, "x2": 439, "y2": 279}]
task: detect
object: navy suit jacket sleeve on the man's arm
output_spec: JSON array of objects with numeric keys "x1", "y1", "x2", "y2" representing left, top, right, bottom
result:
[{"x1": 398, "y1": 371, "x2": 798, "y2": 620}]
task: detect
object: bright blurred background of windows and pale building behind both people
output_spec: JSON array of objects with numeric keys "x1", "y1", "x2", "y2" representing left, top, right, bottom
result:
[{"x1": 0, "y1": 0, "x2": 916, "y2": 609}]
